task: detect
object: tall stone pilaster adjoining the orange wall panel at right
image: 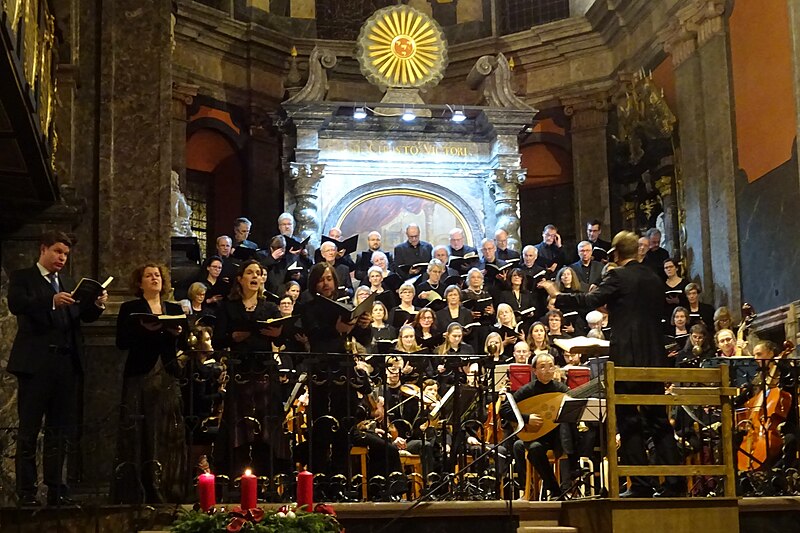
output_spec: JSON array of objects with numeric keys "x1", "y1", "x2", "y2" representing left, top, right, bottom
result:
[{"x1": 660, "y1": 0, "x2": 741, "y2": 309}]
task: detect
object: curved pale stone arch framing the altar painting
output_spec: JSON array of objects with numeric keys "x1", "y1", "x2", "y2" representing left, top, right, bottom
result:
[{"x1": 321, "y1": 179, "x2": 484, "y2": 246}]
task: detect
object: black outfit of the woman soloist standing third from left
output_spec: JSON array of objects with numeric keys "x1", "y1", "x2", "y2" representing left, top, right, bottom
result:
[{"x1": 213, "y1": 299, "x2": 292, "y2": 477}]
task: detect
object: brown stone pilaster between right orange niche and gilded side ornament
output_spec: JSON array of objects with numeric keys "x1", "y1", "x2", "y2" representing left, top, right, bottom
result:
[{"x1": 561, "y1": 91, "x2": 611, "y2": 236}]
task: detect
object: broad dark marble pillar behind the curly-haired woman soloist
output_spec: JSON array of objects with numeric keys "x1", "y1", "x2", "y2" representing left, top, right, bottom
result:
[{"x1": 97, "y1": 0, "x2": 173, "y2": 280}]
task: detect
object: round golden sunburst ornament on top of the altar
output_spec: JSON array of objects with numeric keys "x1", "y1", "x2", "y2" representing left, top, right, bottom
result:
[{"x1": 358, "y1": 5, "x2": 447, "y2": 87}]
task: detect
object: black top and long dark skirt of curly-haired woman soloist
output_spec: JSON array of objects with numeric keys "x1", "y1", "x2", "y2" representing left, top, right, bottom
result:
[{"x1": 111, "y1": 298, "x2": 186, "y2": 504}]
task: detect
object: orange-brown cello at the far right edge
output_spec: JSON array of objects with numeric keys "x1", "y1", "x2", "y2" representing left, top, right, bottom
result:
[{"x1": 736, "y1": 341, "x2": 794, "y2": 472}]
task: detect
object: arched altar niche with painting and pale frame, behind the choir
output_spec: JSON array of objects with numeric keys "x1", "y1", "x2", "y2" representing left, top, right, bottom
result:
[{"x1": 322, "y1": 180, "x2": 483, "y2": 250}]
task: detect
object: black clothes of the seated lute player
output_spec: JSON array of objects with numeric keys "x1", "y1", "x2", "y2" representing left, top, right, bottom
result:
[{"x1": 500, "y1": 379, "x2": 569, "y2": 495}]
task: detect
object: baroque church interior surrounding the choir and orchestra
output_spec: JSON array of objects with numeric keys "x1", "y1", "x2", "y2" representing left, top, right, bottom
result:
[{"x1": 0, "y1": 0, "x2": 800, "y2": 533}]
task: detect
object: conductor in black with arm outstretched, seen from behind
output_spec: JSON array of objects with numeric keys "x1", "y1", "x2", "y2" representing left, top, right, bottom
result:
[{"x1": 540, "y1": 231, "x2": 686, "y2": 497}]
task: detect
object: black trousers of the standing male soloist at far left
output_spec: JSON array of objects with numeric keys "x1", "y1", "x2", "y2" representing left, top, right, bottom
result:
[{"x1": 15, "y1": 353, "x2": 78, "y2": 496}]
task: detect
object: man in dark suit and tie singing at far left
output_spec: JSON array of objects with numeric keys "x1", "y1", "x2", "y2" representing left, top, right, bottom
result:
[{"x1": 7, "y1": 231, "x2": 108, "y2": 506}]
